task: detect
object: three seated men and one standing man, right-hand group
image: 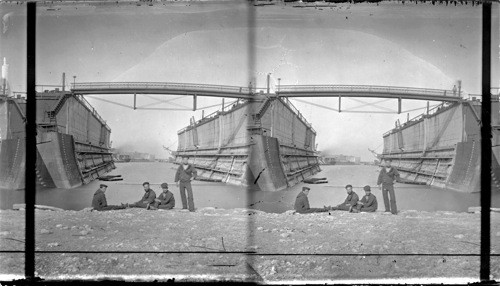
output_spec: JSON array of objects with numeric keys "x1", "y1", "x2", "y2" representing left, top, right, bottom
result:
[{"x1": 295, "y1": 159, "x2": 399, "y2": 214}]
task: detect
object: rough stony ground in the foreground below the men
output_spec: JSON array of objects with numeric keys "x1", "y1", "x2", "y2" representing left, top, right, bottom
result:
[{"x1": 0, "y1": 208, "x2": 500, "y2": 282}]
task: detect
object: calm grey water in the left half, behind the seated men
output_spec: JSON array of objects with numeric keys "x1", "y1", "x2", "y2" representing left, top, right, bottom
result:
[{"x1": 0, "y1": 162, "x2": 246, "y2": 210}]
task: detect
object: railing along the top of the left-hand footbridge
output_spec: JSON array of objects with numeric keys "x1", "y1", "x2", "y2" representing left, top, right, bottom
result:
[{"x1": 71, "y1": 82, "x2": 251, "y2": 94}]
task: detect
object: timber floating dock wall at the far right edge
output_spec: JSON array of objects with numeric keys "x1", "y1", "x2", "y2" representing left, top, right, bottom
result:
[{"x1": 381, "y1": 96, "x2": 500, "y2": 192}]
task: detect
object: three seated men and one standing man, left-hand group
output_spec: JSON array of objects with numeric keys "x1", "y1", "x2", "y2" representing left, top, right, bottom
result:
[{"x1": 92, "y1": 157, "x2": 197, "y2": 212}]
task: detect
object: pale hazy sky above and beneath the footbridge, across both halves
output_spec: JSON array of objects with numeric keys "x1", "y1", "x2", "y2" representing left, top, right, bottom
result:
[{"x1": 0, "y1": 1, "x2": 500, "y2": 161}]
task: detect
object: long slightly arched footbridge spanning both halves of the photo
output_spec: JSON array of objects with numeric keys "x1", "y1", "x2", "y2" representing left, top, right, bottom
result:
[{"x1": 71, "y1": 82, "x2": 464, "y2": 113}]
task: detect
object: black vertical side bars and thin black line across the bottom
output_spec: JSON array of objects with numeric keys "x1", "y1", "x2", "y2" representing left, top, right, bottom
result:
[{"x1": 0, "y1": 0, "x2": 500, "y2": 285}]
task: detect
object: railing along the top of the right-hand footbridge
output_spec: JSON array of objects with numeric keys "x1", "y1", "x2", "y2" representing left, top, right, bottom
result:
[{"x1": 278, "y1": 85, "x2": 458, "y2": 97}]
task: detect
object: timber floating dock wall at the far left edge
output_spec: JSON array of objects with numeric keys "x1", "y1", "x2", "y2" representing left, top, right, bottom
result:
[{"x1": 0, "y1": 89, "x2": 115, "y2": 189}]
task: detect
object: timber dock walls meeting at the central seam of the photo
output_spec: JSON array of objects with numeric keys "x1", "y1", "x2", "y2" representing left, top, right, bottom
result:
[{"x1": 176, "y1": 94, "x2": 320, "y2": 191}]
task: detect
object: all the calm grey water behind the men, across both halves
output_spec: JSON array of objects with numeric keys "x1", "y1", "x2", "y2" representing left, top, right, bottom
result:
[{"x1": 0, "y1": 162, "x2": 500, "y2": 212}]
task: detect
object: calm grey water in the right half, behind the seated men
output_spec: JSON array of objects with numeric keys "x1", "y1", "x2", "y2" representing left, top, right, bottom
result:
[{"x1": 254, "y1": 166, "x2": 500, "y2": 212}]
